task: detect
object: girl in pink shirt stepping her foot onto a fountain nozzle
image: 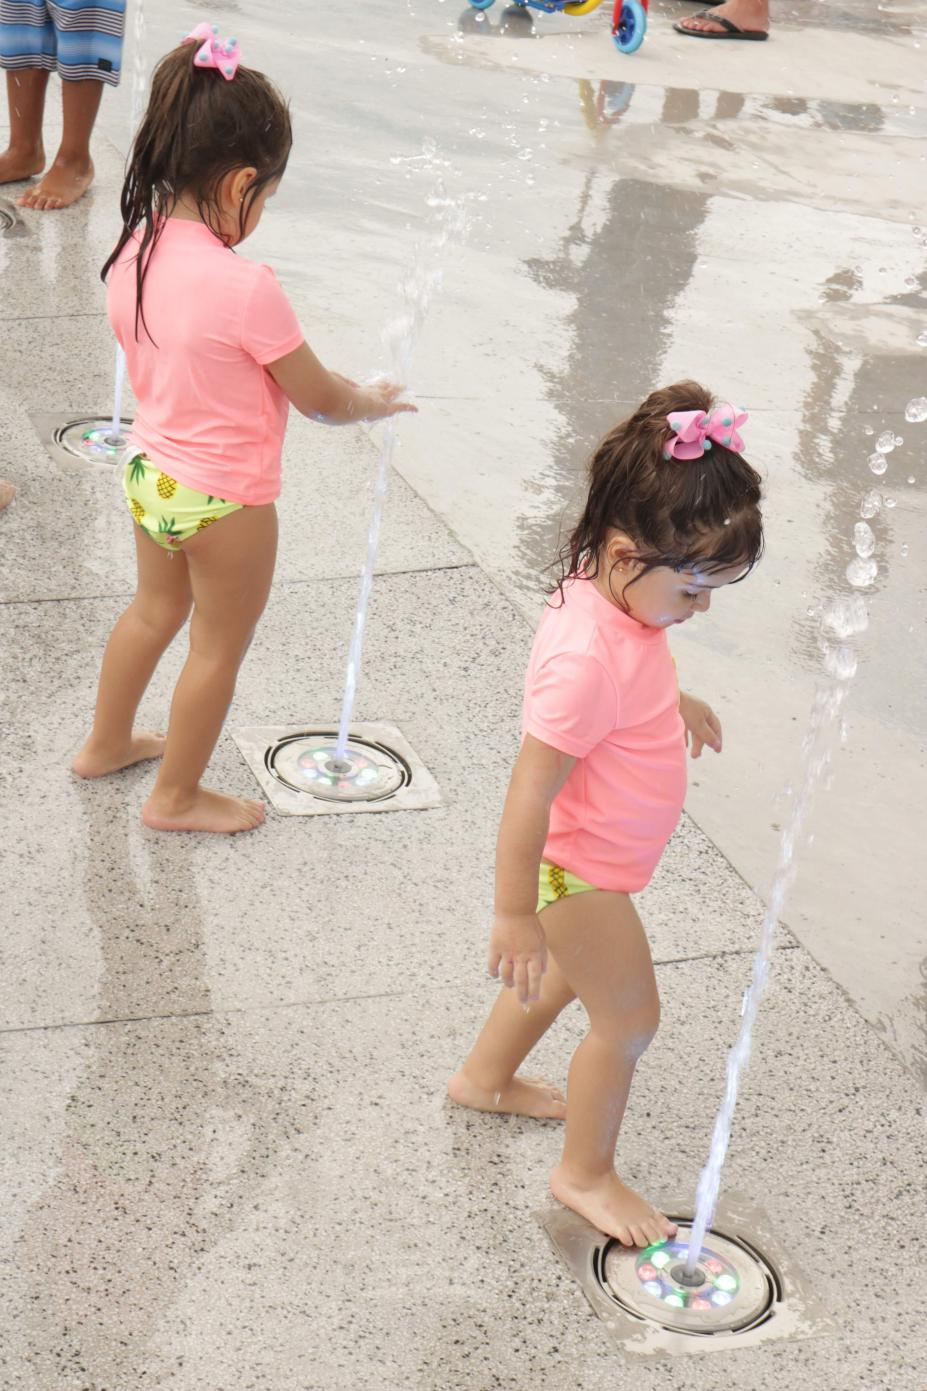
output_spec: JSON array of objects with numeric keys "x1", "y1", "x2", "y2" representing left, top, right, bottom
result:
[{"x1": 448, "y1": 381, "x2": 763, "y2": 1246}]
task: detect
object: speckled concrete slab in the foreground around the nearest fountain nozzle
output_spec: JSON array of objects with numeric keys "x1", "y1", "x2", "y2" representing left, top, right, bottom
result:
[{"x1": 0, "y1": 951, "x2": 927, "y2": 1391}]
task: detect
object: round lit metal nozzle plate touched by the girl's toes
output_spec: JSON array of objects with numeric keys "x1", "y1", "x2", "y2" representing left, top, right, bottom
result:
[{"x1": 604, "y1": 1223, "x2": 777, "y2": 1334}]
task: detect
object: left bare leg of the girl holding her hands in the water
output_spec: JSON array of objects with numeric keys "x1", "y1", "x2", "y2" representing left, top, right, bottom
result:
[{"x1": 71, "y1": 526, "x2": 192, "y2": 778}]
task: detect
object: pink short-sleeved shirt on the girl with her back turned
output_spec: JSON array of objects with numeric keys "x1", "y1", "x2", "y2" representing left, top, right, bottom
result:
[{"x1": 107, "y1": 217, "x2": 303, "y2": 506}]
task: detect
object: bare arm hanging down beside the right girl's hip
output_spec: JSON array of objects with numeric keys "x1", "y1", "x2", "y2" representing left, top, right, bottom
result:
[{"x1": 489, "y1": 734, "x2": 576, "y2": 1004}]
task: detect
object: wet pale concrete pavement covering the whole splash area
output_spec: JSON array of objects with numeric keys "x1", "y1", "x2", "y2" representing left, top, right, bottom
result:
[{"x1": 0, "y1": 0, "x2": 927, "y2": 1391}]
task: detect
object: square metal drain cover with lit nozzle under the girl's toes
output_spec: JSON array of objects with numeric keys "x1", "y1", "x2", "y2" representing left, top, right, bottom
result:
[{"x1": 537, "y1": 1193, "x2": 835, "y2": 1358}]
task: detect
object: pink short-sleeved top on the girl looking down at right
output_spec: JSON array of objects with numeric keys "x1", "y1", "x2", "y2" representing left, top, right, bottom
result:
[{"x1": 523, "y1": 579, "x2": 686, "y2": 893}]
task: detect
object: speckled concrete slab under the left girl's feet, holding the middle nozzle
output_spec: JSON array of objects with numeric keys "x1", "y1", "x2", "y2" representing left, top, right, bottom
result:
[{"x1": 0, "y1": 569, "x2": 785, "y2": 1027}]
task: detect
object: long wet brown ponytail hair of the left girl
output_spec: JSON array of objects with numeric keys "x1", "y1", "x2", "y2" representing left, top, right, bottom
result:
[{"x1": 100, "y1": 43, "x2": 292, "y2": 338}]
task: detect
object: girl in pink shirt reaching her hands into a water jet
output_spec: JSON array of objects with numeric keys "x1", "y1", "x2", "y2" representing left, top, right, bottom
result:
[{"x1": 74, "y1": 25, "x2": 415, "y2": 832}]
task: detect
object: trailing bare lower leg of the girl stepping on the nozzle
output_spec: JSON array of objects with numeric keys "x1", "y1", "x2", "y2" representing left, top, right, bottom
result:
[{"x1": 447, "y1": 957, "x2": 573, "y2": 1120}]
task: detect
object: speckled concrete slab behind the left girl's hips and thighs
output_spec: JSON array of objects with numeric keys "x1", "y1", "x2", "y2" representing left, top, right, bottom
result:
[{"x1": 0, "y1": 338, "x2": 472, "y2": 601}]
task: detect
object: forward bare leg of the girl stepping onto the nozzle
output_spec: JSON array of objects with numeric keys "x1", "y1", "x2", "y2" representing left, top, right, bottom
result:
[{"x1": 541, "y1": 893, "x2": 675, "y2": 1246}]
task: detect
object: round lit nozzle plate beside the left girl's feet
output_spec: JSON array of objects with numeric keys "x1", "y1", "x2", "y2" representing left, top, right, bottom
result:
[{"x1": 264, "y1": 730, "x2": 412, "y2": 801}]
